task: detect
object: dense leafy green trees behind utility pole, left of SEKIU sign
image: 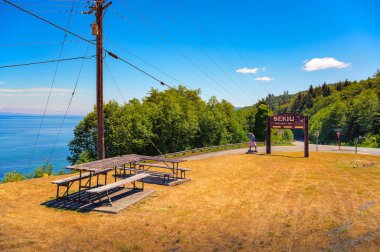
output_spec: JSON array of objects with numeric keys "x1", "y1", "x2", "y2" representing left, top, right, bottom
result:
[{"x1": 68, "y1": 86, "x2": 289, "y2": 164}]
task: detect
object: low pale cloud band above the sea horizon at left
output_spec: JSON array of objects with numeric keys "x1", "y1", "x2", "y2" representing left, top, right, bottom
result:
[{"x1": 0, "y1": 88, "x2": 72, "y2": 97}]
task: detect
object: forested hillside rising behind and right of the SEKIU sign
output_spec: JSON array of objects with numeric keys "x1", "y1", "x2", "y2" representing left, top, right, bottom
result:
[{"x1": 261, "y1": 71, "x2": 380, "y2": 147}]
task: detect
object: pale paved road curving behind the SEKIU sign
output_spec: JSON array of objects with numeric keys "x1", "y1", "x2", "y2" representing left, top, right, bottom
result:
[{"x1": 186, "y1": 141, "x2": 380, "y2": 160}]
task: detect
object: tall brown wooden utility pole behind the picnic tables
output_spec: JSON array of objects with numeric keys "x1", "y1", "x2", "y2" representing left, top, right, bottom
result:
[{"x1": 85, "y1": 0, "x2": 112, "y2": 160}]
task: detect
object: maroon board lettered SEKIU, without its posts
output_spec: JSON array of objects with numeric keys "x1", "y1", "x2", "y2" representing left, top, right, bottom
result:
[{"x1": 270, "y1": 113, "x2": 305, "y2": 129}]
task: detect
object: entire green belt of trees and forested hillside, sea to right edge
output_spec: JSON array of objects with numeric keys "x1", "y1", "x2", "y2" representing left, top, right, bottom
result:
[{"x1": 68, "y1": 71, "x2": 380, "y2": 163}]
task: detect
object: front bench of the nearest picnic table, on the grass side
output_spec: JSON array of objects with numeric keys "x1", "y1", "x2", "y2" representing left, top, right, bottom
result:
[{"x1": 86, "y1": 173, "x2": 150, "y2": 206}]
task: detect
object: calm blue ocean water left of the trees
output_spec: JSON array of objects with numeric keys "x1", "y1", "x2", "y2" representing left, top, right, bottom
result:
[{"x1": 0, "y1": 115, "x2": 83, "y2": 181}]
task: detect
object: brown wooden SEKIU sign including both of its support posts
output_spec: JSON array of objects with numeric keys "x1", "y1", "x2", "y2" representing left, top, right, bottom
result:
[{"x1": 266, "y1": 113, "x2": 309, "y2": 157}]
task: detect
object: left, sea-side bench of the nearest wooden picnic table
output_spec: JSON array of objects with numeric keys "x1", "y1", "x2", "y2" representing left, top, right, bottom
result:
[{"x1": 51, "y1": 168, "x2": 113, "y2": 199}]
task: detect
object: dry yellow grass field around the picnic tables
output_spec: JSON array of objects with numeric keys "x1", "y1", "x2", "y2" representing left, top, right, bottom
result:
[{"x1": 0, "y1": 153, "x2": 380, "y2": 251}]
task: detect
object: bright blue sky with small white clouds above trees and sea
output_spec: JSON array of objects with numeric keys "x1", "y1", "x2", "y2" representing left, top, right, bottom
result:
[{"x1": 0, "y1": 0, "x2": 380, "y2": 114}]
